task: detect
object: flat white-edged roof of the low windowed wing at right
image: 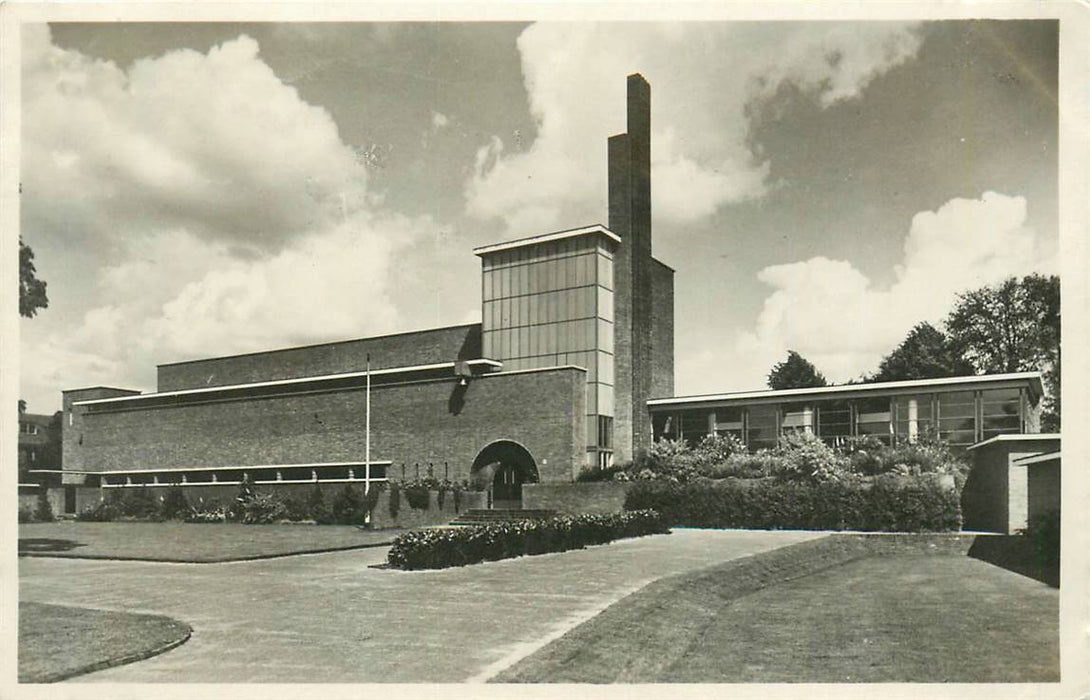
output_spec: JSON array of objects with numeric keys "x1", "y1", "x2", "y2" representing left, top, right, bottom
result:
[{"x1": 647, "y1": 372, "x2": 1041, "y2": 408}]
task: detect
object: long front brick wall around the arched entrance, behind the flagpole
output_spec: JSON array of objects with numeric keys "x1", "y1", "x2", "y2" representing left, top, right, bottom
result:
[{"x1": 64, "y1": 367, "x2": 586, "y2": 481}]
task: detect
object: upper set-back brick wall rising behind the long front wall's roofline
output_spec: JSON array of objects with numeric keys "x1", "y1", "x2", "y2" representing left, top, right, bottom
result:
[{"x1": 158, "y1": 324, "x2": 481, "y2": 391}]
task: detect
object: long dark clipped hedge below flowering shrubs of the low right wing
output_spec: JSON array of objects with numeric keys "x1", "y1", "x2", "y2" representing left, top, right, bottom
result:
[{"x1": 625, "y1": 476, "x2": 961, "y2": 532}]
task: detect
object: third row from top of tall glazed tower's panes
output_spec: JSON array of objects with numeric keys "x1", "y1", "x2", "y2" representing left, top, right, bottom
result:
[{"x1": 482, "y1": 318, "x2": 614, "y2": 362}]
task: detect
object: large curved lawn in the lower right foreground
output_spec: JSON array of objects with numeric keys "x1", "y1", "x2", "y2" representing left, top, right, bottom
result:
[{"x1": 494, "y1": 538, "x2": 1059, "y2": 683}]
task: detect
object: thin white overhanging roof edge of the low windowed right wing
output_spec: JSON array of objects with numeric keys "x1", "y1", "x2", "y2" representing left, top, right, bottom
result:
[{"x1": 647, "y1": 372, "x2": 1042, "y2": 409}]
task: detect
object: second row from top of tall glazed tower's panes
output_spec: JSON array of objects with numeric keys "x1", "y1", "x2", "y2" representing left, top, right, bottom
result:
[{"x1": 482, "y1": 287, "x2": 614, "y2": 330}]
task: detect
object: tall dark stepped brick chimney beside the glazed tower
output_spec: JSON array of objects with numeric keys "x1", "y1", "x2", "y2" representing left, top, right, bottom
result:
[{"x1": 609, "y1": 73, "x2": 654, "y2": 461}]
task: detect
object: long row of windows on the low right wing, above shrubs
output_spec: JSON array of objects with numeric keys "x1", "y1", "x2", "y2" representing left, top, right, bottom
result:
[{"x1": 653, "y1": 389, "x2": 1025, "y2": 449}]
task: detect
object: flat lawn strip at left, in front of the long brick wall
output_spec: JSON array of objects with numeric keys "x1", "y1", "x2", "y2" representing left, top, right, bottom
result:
[{"x1": 19, "y1": 521, "x2": 400, "y2": 564}]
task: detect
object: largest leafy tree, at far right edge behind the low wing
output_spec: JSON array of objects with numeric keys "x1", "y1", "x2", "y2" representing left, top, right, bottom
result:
[{"x1": 946, "y1": 275, "x2": 1059, "y2": 431}]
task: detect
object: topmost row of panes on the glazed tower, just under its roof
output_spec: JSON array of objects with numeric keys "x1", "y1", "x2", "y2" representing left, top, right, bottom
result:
[{"x1": 482, "y1": 253, "x2": 613, "y2": 301}]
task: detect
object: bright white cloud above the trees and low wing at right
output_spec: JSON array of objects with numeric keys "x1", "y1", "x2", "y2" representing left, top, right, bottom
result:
[{"x1": 710, "y1": 192, "x2": 1051, "y2": 386}]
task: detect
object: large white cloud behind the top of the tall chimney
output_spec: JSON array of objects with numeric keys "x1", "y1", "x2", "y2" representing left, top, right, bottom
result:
[{"x1": 465, "y1": 22, "x2": 920, "y2": 232}]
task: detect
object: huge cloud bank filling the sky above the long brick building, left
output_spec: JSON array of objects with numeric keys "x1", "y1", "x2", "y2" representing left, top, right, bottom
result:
[{"x1": 22, "y1": 25, "x2": 434, "y2": 408}]
